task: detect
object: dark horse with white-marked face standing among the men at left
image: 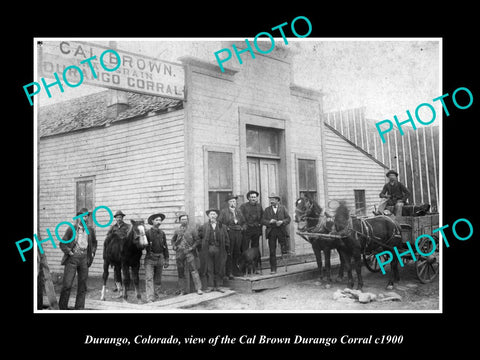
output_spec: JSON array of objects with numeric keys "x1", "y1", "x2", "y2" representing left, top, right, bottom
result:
[{"x1": 101, "y1": 220, "x2": 145, "y2": 300}]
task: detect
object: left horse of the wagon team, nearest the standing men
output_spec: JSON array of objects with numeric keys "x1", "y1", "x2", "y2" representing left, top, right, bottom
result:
[{"x1": 295, "y1": 196, "x2": 343, "y2": 287}]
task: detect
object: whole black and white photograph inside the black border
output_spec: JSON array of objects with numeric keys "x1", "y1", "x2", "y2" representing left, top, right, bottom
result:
[{"x1": 32, "y1": 37, "x2": 442, "y2": 313}]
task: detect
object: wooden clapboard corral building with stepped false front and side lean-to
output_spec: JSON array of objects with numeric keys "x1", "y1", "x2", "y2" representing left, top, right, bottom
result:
[{"x1": 38, "y1": 44, "x2": 387, "y2": 276}]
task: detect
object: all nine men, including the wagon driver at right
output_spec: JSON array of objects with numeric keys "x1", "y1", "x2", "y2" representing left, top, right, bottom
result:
[{"x1": 53, "y1": 170, "x2": 410, "y2": 309}]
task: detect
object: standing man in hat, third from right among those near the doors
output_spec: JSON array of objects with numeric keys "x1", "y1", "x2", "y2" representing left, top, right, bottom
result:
[{"x1": 218, "y1": 195, "x2": 246, "y2": 280}]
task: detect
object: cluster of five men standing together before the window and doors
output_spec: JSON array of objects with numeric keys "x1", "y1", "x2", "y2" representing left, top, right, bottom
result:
[{"x1": 172, "y1": 190, "x2": 290, "y2": 295}]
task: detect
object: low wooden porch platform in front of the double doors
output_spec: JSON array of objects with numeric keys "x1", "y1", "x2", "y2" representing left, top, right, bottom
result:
[{"x1": 224, "y1": 261, "x2": 318, "y2": 292}]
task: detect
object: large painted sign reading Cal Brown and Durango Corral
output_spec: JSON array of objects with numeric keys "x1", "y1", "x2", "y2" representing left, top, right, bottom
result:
[{"x1": 38, "y1": 40, "x2": 185, "y2": 100}]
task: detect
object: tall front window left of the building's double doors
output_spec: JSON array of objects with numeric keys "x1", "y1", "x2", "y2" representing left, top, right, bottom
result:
[{"x1": 208, "y1": 151, "x2": 233, "y2": 209}]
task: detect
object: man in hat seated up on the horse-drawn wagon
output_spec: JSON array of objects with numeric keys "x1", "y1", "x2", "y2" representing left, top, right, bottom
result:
[{"x1": 378, "y1": 170, "x2": 410, "y2": 216}]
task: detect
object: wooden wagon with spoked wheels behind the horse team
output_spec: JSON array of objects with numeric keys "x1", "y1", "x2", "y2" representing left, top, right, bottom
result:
[{"x1": 362, "y1": 214, "x2": 439, "y2": 284}]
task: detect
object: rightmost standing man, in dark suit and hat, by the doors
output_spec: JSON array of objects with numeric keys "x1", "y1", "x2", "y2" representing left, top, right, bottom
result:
[{"x1": 262, "y1": 194, "x2": 290, "y2": 274}]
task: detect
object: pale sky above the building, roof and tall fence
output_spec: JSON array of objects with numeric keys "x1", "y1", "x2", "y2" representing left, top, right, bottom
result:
[{"x1": 40, "y1": 38, "x2": 441, "y2": 120}]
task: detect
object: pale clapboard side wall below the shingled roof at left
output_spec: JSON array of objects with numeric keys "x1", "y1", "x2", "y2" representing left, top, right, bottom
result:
[{"x1": 39, "y1": 110, "x2": 185, "y2": 275}]
